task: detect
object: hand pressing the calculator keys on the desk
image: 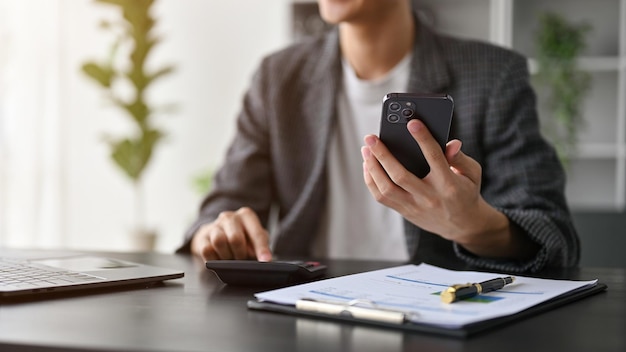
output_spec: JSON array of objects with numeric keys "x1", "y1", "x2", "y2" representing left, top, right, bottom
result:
[{"x1": 191, "y1": 207, "x2": 272, "y2": 261}]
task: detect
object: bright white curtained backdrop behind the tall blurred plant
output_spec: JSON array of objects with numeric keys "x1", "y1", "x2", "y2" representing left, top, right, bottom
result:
[{"x1": 0, "y1": 0, "x2": 291, "y2": 252}]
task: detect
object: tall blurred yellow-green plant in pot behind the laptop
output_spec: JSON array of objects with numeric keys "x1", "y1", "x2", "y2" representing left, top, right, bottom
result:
[{"x1": 82, "y1": 0, "x2": 174, "y2": 249}]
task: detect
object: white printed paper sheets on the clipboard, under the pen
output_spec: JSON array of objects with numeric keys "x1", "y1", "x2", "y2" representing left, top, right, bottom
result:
[{"x1": 255, "y1": 264, "x2": 598, "y2": 328}]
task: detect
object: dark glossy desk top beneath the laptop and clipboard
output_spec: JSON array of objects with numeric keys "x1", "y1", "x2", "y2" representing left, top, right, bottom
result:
[{"x1": 0, "y1": 251, "x2": 626, "y2": 352}]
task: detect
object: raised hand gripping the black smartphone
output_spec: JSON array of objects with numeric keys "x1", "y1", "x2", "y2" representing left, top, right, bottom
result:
[{"x1": 361, "y1": 119, "x2": 509, "y2": 252}]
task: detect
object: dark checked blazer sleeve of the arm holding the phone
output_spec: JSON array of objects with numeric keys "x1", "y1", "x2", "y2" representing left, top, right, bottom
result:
[{"x1": 455, "y1": 56, "x2": 580, "y2": 272}]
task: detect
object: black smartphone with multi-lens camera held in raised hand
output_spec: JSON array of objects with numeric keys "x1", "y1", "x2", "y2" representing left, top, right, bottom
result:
[{"x1": 380, "y1": 93, "x2": 454, "y2": 178}]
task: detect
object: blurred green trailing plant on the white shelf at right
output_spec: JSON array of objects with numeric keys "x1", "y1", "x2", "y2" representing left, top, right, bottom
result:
[{"x1": 536, "y1": 12, "x2": 591, "y2": 166}]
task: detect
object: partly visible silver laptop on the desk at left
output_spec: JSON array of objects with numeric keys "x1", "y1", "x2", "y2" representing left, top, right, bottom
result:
[{"x1": 0, "y1": 251, "x2": 184, "y2": 300}]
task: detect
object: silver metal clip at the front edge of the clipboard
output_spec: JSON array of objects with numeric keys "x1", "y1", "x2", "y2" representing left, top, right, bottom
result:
[{"x1": 296, "y1": 298, "x2": 417, "y2": 324}]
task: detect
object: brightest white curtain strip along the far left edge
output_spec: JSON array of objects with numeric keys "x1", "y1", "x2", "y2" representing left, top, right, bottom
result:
[{"x1": 0, "y1": 0, "x2": 64, "y2": 247}]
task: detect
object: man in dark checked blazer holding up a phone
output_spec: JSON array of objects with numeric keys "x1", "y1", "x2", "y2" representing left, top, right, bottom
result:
[{"x1": 179, "y1": 0, "x2": 579, "y2": 272}]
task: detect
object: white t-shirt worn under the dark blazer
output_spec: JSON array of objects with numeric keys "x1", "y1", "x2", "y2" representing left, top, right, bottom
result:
[{"x1": 313, "y1": 55, "x2": 411, "y2": 260}]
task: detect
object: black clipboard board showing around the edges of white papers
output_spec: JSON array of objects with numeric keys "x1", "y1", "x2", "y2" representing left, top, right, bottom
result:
[{"x1": 247, "y1": 276, "x2": 608, "y2": 339}]
